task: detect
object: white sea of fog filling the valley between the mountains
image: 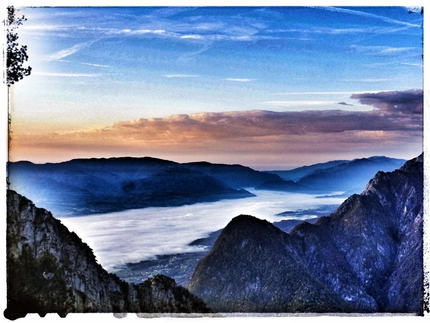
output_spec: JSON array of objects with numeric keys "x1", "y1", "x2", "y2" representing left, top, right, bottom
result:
[{"x1": 59, "y1": 190, "x2": 345, "y2": 271}]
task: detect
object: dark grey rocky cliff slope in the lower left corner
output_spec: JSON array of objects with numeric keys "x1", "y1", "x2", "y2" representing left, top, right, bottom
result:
[{"x1": 5, "y1": 191, "x2": 210, "y2": 319}]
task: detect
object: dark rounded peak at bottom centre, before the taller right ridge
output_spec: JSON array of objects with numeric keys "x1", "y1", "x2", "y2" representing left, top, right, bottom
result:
[{"x1": 189, "y1": 215, "x2": 341, "y2": 312}]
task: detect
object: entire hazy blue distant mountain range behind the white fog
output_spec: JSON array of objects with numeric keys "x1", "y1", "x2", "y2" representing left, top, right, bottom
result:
[{"x1": 8, "y1": 157, "x2": 406, "y2": 216}]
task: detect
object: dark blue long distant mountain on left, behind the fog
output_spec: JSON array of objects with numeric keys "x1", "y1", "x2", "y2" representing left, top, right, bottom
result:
[{"x1": 9, "y1": 157, "x2": 252, "y2": 216}]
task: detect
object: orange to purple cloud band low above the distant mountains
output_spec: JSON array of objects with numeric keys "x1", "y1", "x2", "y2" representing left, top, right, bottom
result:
[{"x1": 11, "y1": 91, "x2": 423, "y2": 168}]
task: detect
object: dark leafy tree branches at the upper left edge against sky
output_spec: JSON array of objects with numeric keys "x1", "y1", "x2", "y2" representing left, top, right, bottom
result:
[{"x1": 5, "y1": 6, "x2": 31, "y2": 86}]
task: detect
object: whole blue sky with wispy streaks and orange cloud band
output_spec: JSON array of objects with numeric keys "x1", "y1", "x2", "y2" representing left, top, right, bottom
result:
[{"x1": 5, "y1": 6, "x2": 423, "y2": 169}]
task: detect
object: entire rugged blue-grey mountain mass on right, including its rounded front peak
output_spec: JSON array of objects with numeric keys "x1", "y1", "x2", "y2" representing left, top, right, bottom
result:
[{"x1": 188, "y1": 155, "x2": 423, "y2": 314}]
